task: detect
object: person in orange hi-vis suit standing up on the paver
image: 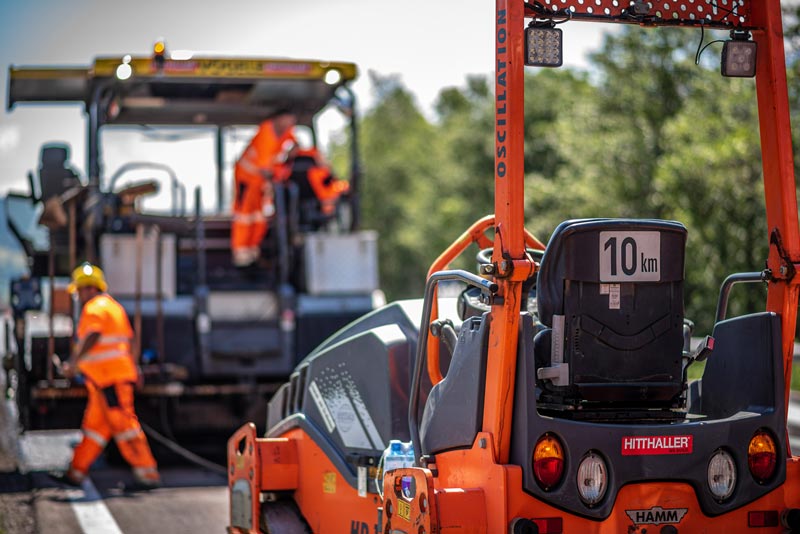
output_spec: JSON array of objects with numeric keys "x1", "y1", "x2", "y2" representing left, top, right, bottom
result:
[{"x1": 231, "y1": 110, "x2": 297, "y2": 267}]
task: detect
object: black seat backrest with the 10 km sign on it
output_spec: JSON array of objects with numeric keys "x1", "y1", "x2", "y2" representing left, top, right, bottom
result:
[{"x1": 536, "y1": 219, "x2": 686, "y2": 404}]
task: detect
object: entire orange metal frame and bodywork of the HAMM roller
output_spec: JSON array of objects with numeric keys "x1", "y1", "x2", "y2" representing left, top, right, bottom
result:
[{"x1": 228, "y1": 0, "x2": 800, "y2": 534}]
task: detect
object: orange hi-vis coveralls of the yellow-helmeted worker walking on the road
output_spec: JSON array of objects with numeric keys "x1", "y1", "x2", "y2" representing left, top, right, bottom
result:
[{"x1": 68, "y1": 293, "x2": 159, "y2": 483}]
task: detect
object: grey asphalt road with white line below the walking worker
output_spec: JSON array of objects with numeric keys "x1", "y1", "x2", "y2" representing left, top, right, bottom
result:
[{"x1": 0, "y1": 395, "x2": 800, "y2": 534}]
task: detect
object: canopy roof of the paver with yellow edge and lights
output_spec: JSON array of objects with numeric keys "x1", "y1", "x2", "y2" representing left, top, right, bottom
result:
[{"x1": 7, "y1": 56, "x2": 357, "y2": 125}]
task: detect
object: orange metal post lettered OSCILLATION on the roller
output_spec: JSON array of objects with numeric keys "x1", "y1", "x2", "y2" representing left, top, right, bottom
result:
[{"x1": 483, "y1": 0, "x2": 533, "y2": 463}]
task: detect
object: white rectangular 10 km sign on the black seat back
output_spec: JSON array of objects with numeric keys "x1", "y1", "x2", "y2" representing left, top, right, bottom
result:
[{"x1": 600, "y1": 231, "x2": 661, "y2": 283}]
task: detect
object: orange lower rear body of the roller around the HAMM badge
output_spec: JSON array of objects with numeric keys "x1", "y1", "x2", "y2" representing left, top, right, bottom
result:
[{"x1": 416, "y1": 433, "x2": 800, "y2": 534}]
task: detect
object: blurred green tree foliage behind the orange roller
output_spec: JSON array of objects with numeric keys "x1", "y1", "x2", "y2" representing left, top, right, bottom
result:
[{"x1": 346, "y1": 24, "x2": 800, "y2": 332}]
